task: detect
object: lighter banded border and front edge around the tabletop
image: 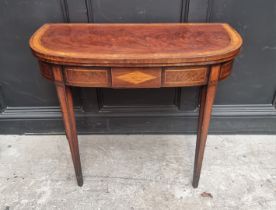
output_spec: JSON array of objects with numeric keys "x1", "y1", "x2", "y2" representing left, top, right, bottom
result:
[{"x1": 29, "y1": 23, "x2": 242, "y2": 66}]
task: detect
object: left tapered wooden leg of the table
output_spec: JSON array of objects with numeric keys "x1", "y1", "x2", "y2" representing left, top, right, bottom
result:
[{"x1": 53, "y1": 67, "x2": 83, "y2": 186}]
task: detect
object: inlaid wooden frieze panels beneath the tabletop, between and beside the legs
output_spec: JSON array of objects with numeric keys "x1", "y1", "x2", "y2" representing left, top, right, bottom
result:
[{"x1": 40, "y1": 61, "x2": 230, "y2": 88}]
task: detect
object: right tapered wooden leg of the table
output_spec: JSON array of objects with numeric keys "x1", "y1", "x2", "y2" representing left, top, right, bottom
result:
[{"x1": 192, "y1": 65, "x2": 220, "y2": 188}]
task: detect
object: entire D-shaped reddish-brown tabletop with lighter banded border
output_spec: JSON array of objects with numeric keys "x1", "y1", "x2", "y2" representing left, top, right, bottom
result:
[{"x1": 30, "y1": 24, "x2": 242, "y2": 64}]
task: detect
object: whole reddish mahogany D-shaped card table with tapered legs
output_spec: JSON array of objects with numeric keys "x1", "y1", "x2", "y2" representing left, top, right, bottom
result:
[{"x1": 30, "y1": 23, "x2": 242, "y2": 188}]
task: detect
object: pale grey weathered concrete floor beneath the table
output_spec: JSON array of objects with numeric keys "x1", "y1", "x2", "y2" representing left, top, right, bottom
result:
[{"x1": 0, "y1": 135, "x2": 276, "y2": 210}]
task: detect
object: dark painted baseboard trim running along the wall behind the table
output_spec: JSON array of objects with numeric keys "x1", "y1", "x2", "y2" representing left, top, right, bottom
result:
[{"x1": 0, "y1": 104, "x2": 276, "y2": 134}]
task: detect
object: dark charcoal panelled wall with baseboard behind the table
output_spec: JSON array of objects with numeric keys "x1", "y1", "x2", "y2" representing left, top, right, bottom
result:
[{"x1": 0, "y1": 0, "x2": 276, "y2": 134}]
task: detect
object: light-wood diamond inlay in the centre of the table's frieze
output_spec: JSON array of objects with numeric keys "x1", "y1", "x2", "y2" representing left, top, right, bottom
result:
[{"x1": 117, "y1": 71, "x2": 156, "y2": 85}]
